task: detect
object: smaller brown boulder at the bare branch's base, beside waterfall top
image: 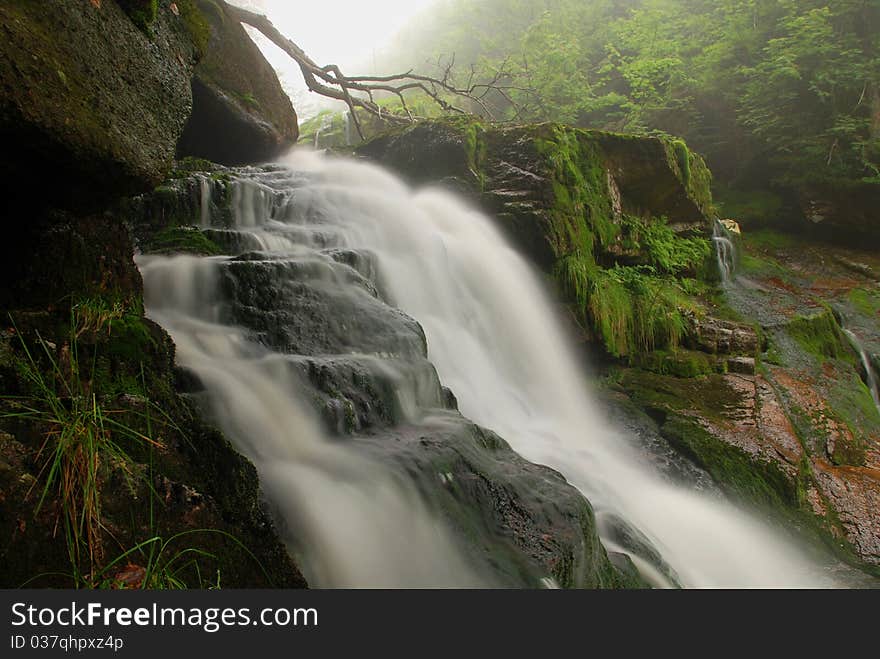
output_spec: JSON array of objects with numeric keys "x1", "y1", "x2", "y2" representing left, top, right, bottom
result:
[{"x1": 178, "y1": 2, "x2": 299, "y2": 165}]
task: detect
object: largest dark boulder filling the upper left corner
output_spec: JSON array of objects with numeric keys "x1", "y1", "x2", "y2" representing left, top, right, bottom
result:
[{"x1": 0, "y1": 0, "x2": 197, "y2": 211}]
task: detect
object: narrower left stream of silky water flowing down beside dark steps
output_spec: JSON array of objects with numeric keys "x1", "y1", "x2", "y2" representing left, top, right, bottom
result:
[{"x1": 139, "y1": 255, "x2": 491, "y2": 588}]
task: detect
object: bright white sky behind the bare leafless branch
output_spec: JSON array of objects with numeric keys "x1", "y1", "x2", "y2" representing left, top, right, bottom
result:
[{"x1": 232, "y1": 0, "x2": 436, "y2": 120}]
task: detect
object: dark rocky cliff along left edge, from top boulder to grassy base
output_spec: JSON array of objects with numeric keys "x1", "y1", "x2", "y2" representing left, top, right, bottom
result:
[{"x1": 0, "y1": 0, "x2": 305, "y2": 588}]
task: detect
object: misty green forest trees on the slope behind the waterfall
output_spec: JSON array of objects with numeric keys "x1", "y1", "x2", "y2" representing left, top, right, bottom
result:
[{"x1": 387, "y1": 0, "x2": 880, "y2": 201}]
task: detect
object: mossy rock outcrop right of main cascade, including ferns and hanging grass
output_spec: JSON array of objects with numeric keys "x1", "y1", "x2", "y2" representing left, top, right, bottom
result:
[{"x1": 358, "y1": 118, "x2": 714, "y2": 358}]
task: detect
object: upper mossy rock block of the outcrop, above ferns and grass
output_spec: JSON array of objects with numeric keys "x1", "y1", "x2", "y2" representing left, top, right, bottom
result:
[{"x1": 358, "y1": 118, "x2": 712, "y2": 270}]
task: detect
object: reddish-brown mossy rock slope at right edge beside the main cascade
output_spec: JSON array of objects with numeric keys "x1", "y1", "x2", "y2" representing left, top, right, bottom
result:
[{"x1": 622, "y1": 232, "x2": 880, "y2": 566}]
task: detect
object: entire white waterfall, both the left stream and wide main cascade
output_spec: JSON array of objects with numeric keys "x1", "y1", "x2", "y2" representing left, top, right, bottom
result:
[{"x1": 140, "y1": 153, "x2": 829, "y2": 587}]
